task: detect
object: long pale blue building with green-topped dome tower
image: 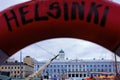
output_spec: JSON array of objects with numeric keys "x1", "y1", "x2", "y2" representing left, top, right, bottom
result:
[{"x1": 34, "y1": 51, "x2": 120, "y2": 80}]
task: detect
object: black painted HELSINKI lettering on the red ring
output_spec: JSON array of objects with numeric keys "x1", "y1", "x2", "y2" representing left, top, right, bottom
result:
[{"x1": 3, "y1": 1, "x2": 109, "y2": 31}]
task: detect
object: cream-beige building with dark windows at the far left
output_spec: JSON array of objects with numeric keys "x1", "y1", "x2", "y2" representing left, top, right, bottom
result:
[{"x1": 0, "y1": 57, "x2": 34, "y2": 78}]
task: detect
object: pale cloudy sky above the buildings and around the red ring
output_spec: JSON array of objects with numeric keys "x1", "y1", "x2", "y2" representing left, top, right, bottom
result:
[{"x1": 0, "y1": 0, "x2": 120, "y2": 61}]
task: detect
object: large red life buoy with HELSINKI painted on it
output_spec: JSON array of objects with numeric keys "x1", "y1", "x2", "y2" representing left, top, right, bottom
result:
[{"x1": 0, "y1": 0, "x2": 120, "y2": 63}]
